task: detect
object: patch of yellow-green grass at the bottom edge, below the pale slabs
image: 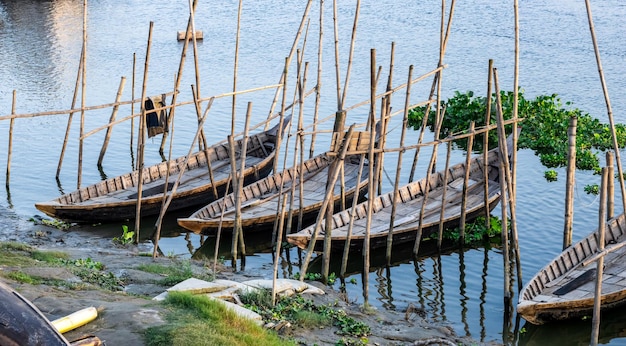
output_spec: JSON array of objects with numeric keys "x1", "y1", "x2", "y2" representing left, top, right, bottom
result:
[{"x1": 145, "y1": 292, "x2": 295, "y2": 346}]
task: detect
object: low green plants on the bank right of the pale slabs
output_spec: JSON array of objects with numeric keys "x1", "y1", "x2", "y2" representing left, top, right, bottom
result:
[{"x1": 240, "y1": 290, "x2": 371, "y2": 344}]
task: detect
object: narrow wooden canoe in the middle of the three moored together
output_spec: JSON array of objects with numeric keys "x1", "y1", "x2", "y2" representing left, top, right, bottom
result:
[{"x1": 178, "y1": 153, "x2": 369, "y2": 235}]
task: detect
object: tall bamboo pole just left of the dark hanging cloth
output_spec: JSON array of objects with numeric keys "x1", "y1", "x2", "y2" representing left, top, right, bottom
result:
[{"x1": 135, "y1": 22, "x2": 157, "y2": 243}]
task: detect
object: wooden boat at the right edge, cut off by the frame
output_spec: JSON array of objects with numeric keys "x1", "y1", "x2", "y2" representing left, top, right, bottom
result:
[{"x1": 517, "y1": 214, "x2": 626, "y2": 324}]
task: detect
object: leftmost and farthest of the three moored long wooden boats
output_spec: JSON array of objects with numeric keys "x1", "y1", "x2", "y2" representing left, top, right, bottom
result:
[{"x1": 35, "y1": 119, "x2": 289, "y2": 223}]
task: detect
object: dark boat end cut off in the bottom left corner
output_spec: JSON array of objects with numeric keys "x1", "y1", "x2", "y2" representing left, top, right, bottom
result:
[{"x1": 0, "y1": 281, "x2": 70, "y2": 345}]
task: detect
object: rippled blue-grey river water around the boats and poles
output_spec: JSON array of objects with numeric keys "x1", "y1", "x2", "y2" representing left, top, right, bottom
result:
[{"x1": 0, "y1": 0, "x2": 626, "y2": 345}]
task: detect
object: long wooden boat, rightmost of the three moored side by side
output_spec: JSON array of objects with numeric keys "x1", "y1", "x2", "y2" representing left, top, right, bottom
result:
[{"x1": 287, "y1": 139, "x2": 500, "y2": 251}]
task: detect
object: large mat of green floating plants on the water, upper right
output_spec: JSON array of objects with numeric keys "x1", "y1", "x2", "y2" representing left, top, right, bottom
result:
[{"x1": 409, "y1": 90, "x2": 626, "y2": 189}]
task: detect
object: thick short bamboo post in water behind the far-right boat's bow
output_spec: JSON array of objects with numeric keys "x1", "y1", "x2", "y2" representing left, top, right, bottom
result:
[{"x1": 563, "y1": 116, "x2": 578, "y2": 250}]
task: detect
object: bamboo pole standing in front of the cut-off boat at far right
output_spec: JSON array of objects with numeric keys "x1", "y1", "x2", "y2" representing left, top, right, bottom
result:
[{"x1": 589, "y1": 167, "x2": 613, "y2": 346}]
